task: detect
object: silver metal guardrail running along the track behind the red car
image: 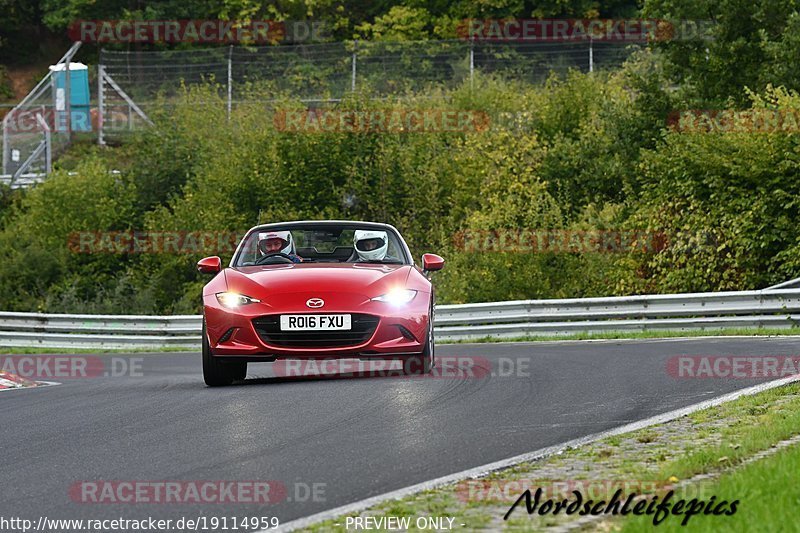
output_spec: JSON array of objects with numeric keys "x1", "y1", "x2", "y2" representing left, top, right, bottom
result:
[{"x1": 0, "y1": 289, "x2": 800, "y2": 350}]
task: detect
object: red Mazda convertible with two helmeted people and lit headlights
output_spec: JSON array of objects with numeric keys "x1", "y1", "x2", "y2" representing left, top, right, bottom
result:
[{"x1": 197, "y1": 221, "x2": 444, "y2": 387}]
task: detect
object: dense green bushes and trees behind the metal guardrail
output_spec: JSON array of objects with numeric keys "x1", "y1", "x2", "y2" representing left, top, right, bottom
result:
[{"x1": 0, "y1": 0, "x2": 800, "y2": 313}]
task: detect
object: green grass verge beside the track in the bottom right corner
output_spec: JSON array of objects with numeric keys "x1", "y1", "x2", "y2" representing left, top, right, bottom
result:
[{"x1": 309, "y1": 383, "x2": 800, "y2": 531}]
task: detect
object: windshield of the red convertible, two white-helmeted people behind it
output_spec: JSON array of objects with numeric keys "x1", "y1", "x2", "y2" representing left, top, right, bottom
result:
[{"x1": 233, "y1": 223, "x2": 410, "y2": 267}]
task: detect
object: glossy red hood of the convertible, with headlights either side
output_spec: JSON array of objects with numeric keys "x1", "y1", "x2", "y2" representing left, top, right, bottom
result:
[{"x1": 225, "y1": 263, "x2": 413, "y2": 304}]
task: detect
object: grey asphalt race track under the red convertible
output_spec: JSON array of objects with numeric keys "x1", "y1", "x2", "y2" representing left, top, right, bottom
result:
[{"x1": 0, "y1": 338, "x2": 800, "y2": 522}]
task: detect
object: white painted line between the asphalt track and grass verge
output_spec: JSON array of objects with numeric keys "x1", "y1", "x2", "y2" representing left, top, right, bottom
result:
[{"x1": 268, "y1": 374, "x2": 800, "y2": 533}]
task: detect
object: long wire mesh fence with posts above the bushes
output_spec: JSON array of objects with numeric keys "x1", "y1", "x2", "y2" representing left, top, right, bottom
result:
[{"x1": 99, "y1": 40, "x2": 639, "y2": 142}]
